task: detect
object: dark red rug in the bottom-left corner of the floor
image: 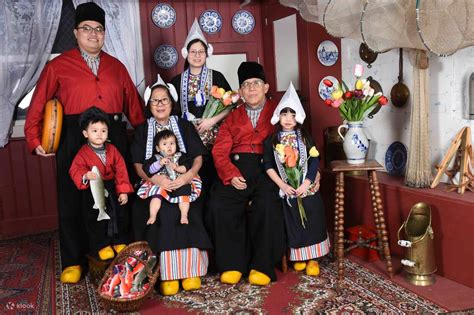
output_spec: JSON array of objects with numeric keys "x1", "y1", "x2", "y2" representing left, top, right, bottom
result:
[{"x1": 0, "y1": 233, "x2": 57, "y2": 314}]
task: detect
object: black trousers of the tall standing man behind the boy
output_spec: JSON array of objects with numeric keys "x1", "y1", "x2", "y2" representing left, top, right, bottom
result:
[{"x1": 56, "y1": 114, "x2": 127, "y2": 268}]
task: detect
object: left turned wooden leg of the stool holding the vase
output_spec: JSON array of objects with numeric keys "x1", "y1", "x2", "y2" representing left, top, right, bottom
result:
[{"x1": 334, "y1": 172, "x2": 344, "y2": 280}]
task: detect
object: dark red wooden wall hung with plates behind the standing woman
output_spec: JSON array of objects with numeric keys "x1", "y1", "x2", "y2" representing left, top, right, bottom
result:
[{"x1": 140, "y1": 0, "x2": 264, "y2": 85}]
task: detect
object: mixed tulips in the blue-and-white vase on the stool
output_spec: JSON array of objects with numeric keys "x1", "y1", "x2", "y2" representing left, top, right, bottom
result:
[{"x1": 323, "y1": 65, "x2": 388, "y2": 121}]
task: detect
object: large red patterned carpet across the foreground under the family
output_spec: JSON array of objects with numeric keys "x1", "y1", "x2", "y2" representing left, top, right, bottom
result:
[{"x1": 50, "y1": 237, "x2": 446, "y2": 314}]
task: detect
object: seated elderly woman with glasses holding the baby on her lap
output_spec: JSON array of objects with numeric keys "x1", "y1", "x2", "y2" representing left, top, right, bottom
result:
[{"x1": 131, "y1": 76, "x2": 212, "y2": 295}]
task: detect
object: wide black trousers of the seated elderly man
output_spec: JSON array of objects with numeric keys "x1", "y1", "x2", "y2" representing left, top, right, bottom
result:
[{"x1": 209, "y1": 153, "x2": 286, "y2": 281}]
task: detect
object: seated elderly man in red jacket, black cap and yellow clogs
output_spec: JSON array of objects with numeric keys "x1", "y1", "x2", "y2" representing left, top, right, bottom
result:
[{"x1": 209, "y1": 62, "x2": 285, "y2": 285}]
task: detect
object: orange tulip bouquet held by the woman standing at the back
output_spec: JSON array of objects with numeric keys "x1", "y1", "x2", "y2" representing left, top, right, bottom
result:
[{"x1": 193, "y1": 85, "x2": 240, "y2": 149}]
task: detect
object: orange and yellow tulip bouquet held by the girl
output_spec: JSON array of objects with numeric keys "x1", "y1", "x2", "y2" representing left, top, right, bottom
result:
[{"x1": 275, "y1": 135, "x2": 319, "y2": 228}]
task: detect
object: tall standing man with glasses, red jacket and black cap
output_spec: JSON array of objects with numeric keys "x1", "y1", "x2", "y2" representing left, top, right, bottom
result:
[{"x1": 25, "y1": 2, "x2": 144, "y2": 283}]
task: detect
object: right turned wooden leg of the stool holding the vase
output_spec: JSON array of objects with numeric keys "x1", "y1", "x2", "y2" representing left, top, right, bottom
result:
[{"x1": 370, "y1": 171, "x2": 393, "y2": 278}]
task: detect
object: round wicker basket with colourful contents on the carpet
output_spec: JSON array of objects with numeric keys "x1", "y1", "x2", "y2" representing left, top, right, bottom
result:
[{"x1": 97, "y1": 242, "x2": 159, "y2": 312}]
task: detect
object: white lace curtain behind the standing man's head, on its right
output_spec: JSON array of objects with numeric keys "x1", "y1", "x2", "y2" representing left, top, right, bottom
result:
[{"x1": 72, "y1": 0, "x2": 145, "y2": 95}]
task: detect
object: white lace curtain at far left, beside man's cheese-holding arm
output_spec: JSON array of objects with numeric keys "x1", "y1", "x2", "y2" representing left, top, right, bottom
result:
[{"x1": 0, "y1": 0, "x2": 62, "y2": 148}]
